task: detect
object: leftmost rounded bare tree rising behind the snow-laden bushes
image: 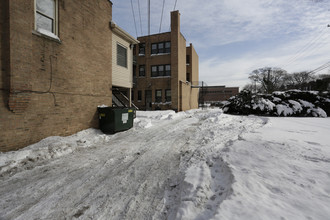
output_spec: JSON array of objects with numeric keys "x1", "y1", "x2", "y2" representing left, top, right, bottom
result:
[{"x1": 249, "y1": 67, "x2": 287, "y2": 93}]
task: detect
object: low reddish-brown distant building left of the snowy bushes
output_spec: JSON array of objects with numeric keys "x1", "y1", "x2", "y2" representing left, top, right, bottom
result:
[{"x1": 201, "y1": 86, "x2": 239, "y2": 103}]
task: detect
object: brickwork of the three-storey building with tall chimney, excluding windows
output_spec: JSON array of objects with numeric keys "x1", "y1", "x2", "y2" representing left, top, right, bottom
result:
[{"x1": 133, "y1": 11, "x2": 198, "y2": 111}]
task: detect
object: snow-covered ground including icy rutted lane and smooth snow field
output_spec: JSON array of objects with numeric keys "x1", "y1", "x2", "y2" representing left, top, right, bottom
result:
[{"x1": 0, "y1": 110, "x2": 330, "y2": 220}]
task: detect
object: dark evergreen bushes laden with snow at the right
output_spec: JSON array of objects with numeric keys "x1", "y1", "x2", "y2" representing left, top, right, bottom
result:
[{"x1": 223, "y1": 90, "x2": 330, "y2": 117}]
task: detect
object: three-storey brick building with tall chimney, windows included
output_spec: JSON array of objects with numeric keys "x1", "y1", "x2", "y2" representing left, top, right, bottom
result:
[{"x1": 132, "y1": 11, "x2": 198, "y2": 111}]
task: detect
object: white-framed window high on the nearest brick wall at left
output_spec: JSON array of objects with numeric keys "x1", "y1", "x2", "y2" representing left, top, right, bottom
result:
[{"x1": 35, "y1": 0, "x2": 57, "y2": 35}]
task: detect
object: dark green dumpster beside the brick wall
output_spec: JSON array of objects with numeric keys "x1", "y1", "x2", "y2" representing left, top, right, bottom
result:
[{"x1": 97, "y1": 107, "x2": 135, "y2": 134}]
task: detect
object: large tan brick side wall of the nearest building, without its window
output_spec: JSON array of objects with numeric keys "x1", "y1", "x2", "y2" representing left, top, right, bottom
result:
[{"x1": 0, "y1": 0, "x2": 112, "y2": 151}]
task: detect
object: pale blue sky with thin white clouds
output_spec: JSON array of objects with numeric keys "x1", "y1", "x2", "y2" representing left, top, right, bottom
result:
[{"x1": 112, "y1": 0, "x2": 330, "y2": 87}]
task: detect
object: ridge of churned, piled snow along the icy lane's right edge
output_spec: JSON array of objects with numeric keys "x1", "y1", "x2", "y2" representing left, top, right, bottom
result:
[{"x1": 168, "y1": 113, "x2": 267, "y2": 219}]
